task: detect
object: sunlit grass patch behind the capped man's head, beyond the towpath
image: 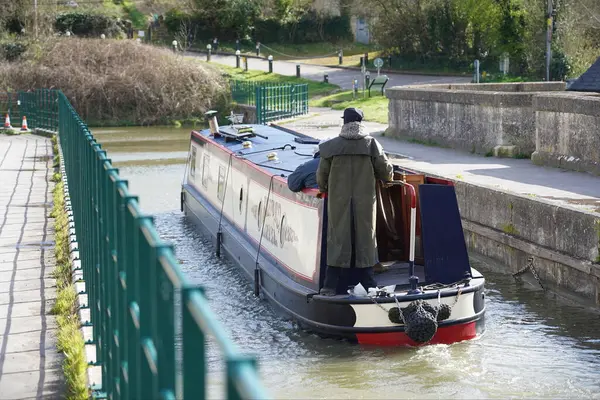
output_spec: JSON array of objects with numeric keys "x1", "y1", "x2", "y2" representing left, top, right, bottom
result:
[{"x1": 309, "y1": 90, "x2": 389, "y2": 124}]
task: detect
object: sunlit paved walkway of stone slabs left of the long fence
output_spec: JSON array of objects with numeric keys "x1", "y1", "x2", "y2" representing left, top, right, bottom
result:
[{"x1": 0, "y1": 134, "x2": 63, "y2": 399}]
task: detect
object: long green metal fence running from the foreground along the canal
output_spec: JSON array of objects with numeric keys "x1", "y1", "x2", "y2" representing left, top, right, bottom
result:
[{"x1": 36, "y1": 92, "x2": 268, "y2": 399}]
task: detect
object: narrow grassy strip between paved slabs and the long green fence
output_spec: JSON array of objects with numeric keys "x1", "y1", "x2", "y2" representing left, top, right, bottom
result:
[{"x1": 50, "y1": 136, "x2": 88, "y2": 400}]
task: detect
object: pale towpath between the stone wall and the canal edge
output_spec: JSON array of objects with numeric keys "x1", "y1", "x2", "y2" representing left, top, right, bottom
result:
[{"x1": 279, "y1": 108, "x2": 600, "y2": 217}]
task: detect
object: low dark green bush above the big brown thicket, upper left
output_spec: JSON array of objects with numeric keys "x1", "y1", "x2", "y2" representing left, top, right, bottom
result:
[{"x1": 54, "y1": 12, "x2": 125, "y2": 37}]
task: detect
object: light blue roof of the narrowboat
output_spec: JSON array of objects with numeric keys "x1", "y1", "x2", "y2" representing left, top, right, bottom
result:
[{"x1": 199, "y1": 124, "x2": 319, "y2": 177}]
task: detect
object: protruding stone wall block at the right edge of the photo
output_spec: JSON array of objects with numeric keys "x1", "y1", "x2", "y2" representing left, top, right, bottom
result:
[{"x1": 531, "y1": 92, "x2": 600, "y2": 175}]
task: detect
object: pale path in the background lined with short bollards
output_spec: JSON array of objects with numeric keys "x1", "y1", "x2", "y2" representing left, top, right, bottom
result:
[{"x1": 206, "y1": 54, "x2": 471, "y2": 89}]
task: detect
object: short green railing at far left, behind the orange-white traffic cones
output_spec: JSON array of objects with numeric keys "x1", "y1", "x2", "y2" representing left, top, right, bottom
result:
[{"x1": 0, "y1": 89, "x2": 58, "y2": 132}]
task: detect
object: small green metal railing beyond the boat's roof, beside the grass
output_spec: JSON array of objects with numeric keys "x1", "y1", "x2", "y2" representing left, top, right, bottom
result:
[{"x1": 256, "y1": 84, "x2": 308, "y2": 124}]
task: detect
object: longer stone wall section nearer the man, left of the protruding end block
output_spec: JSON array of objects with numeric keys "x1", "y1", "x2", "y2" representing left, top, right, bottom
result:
[{"x1": 386, "y1": 82, "x2": 565, "y2": 155}]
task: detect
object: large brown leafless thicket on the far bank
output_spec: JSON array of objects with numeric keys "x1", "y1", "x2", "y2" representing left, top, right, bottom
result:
[{"x1": 0, "y1": 38, "x2": 229, "y2": 125}]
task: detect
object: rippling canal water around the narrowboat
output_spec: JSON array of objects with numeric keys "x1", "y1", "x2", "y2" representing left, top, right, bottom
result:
[{"x1": 93, "y1": 128, "x2": 600, "y2": 399}]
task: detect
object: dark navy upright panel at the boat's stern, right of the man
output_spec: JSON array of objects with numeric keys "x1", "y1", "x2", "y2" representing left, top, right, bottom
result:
[{"x1": 419, "y1": 185, "x2": 471, "y2": 284}]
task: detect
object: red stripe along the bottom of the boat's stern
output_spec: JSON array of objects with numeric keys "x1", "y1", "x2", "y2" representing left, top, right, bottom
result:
[{"x1": 356, "y1": 321, "x2": 477, "y2": 346}]
